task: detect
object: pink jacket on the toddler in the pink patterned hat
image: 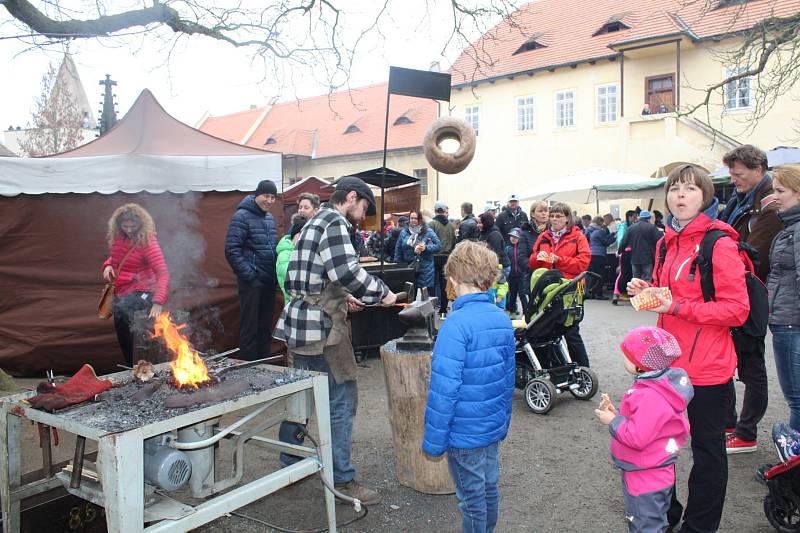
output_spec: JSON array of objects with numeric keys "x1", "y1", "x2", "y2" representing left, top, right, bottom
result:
[{"x1": 608, "y1": 368, "x2": 694, "y2": 496}]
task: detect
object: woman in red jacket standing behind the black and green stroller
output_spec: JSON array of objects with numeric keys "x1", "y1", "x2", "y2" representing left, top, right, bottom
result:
[{"x1": 530, "y1": 203, "x2": 592, "y2": 367}]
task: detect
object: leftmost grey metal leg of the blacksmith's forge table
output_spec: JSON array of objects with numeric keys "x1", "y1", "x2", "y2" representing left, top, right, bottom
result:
[{"x1": 0, "y1": 412, "x2": 22, "y2": 533}]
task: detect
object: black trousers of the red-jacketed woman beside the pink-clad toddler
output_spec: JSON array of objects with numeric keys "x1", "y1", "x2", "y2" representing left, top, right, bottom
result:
[{"x1": 667, "y1": 383, "x2": 731, "y2": 533}]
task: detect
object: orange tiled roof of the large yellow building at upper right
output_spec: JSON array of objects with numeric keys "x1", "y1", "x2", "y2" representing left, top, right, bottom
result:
[{"x1": 451, "y1": 0, "x2": 800, "y2": 85}]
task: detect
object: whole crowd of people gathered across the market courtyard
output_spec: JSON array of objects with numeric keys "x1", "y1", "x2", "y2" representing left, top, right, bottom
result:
[{"x1": 103, "y1": 142, "x2": 800, "y2": 532}]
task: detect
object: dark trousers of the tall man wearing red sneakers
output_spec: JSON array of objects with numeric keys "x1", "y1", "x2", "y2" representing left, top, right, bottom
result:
[{"x1": 726, "y1": 331, "x2": 769, "y2": 441}]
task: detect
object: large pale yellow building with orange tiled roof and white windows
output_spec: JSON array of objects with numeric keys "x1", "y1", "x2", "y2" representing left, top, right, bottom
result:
[{"x1": 439, "y1": 0, "x2": 800, "y2": 209}]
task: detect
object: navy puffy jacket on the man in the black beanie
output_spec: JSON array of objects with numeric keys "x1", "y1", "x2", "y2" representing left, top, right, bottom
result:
[{"x1": 225, "y1": 195, "x2": 278, "y2": 285}]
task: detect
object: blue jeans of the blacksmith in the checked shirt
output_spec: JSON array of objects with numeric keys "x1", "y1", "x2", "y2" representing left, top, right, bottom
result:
[{"x1": 278, "y1": 353, "x2": 358, "y2": 485}]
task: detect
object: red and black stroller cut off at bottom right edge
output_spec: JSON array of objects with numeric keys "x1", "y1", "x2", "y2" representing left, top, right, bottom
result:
[{"x1": 758, "y1": 422, "x2": 800, "y2": 533}]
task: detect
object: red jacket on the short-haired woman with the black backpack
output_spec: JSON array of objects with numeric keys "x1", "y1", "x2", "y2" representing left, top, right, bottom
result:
[{"x1": 653, "y1": 213, "x2": 750, "y2": 385}]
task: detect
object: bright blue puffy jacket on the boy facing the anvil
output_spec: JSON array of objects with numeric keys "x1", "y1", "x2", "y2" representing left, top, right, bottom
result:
[{"x1": 422, "y1": 293, "x2": 514, "y2": 456}]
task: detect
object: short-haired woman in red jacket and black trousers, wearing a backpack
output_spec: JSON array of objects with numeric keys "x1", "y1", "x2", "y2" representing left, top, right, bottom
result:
[{"x1": 628, "y1": 165, "x2": 750, "y2": 531}]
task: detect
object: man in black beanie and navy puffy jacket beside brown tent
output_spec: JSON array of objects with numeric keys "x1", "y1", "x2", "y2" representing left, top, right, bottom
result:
[{"x1": 225, "y1": 180, "x2": 278, "y2": 361}]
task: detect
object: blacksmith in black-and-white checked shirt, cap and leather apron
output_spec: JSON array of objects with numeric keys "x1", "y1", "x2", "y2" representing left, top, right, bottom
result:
[{"x1": 274, "y1": 176, "x2": 396, "y2": 505}]
